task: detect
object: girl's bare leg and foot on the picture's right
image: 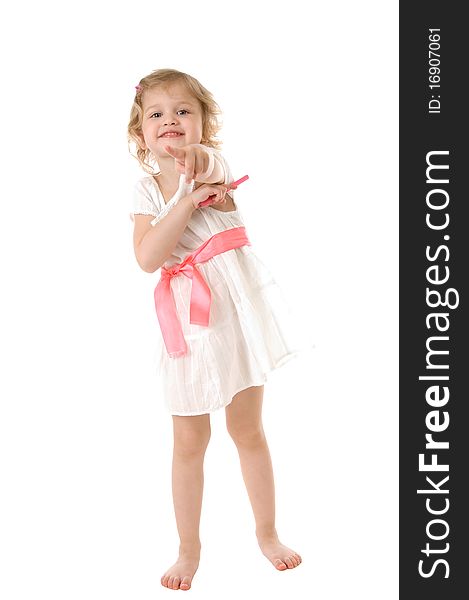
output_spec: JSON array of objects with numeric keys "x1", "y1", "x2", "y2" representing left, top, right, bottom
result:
[{"x1": 225, "y1": 385, "x2": 301, "y2": 571}]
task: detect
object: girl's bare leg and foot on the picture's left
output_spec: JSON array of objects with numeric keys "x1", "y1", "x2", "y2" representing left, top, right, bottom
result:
[{"x1": 161, "y1": 414, "x2": 210, "y2": 590}]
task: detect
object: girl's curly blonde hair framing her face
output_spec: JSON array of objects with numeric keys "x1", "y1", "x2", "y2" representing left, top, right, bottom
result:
[{"x1": 127, "y1": 69, "x2": 222, "y2": 175}]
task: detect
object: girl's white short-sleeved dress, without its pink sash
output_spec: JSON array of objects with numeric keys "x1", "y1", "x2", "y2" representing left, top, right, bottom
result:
[{"x1": 132, "y1": 148, "x2": 306, "y2": 415}]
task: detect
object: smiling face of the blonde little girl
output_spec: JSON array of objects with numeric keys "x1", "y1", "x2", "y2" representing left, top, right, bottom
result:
[{"x1": 142, "y1": 82, "x2": 202, "y2": 160}]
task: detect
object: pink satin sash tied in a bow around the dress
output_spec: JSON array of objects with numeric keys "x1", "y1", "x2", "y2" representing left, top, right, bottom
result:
[{"x1": 155, "y1": 227, "x2": 251, "y2": 358}]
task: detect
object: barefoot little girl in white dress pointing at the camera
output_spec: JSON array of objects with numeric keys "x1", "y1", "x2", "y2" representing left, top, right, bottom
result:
[{"x1": 128, "y1": 69, "x2": 301, "y2": 590}]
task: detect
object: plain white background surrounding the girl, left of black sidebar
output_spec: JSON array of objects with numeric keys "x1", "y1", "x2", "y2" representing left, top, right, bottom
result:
[{"x1": 0, "y1": 0, "x2": 398, "y2": 600}]
